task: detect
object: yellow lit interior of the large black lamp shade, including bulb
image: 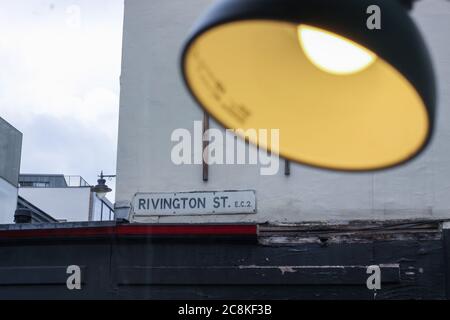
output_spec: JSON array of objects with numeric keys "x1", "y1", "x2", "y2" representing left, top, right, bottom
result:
[{"x1": 185, "y1": 20, "x2": 429, "y2": 170}]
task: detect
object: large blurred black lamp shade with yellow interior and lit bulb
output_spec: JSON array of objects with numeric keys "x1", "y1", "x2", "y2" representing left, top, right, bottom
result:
[{"x1": 182, "y1": 0, "x2": 435, "y2": 171}]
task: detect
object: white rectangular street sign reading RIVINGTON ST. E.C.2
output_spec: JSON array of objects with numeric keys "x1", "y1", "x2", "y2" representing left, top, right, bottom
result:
[{"x1": 133, "y1": 190, "x2": 256, "y2": 216}]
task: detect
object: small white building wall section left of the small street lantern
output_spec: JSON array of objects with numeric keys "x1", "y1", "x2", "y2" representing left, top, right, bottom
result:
[{"x1": 19, "y1": 187, "x2": 91, "y2": 222}]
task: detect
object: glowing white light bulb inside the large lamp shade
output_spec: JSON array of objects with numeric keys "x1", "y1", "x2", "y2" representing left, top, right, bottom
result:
[{"x1": 298, "y1": 25, "x2": 377, "y2": 75}]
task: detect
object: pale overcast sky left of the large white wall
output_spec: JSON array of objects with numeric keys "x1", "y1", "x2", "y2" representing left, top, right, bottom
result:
[{"x1": 0, "y1": 0, "x2": 123, "y2": 198}]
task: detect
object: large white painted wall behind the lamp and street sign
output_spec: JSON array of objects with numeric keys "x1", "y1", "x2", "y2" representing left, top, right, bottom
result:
[{"x1": 116, "y1": 0, "x2": 450, "y2": 222}]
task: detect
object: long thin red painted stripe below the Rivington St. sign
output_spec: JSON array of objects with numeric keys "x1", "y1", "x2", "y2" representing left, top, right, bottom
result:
[{"x1": 0, "y1": 225, "x2": 257, "y2": 239}]
